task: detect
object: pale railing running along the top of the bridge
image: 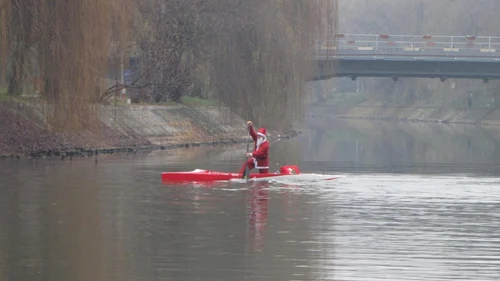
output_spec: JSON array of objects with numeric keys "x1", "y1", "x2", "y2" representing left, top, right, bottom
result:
[{"x1": 317, "y1": 34, "x2": 500, "y2": 56}]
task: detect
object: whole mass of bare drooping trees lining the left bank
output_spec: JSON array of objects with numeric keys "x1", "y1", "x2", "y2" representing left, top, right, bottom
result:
[{"x1": 0, "y1": 0, "x2": 337, "y2": 129}]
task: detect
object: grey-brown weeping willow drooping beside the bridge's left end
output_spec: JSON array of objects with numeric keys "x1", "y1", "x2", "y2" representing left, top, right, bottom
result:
[{"x1": 205, "y1": 0, "x2": 338, "y2": 128}]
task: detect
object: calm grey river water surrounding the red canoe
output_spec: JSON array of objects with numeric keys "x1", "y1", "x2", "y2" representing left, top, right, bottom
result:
[{"x1": 0, "y1": 121, "x2": 500, "y2": 281}]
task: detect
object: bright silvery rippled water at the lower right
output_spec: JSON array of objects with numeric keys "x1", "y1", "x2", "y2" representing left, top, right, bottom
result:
[{"x1": 298, "y1": 175, "x2": 500, "y2": 280}]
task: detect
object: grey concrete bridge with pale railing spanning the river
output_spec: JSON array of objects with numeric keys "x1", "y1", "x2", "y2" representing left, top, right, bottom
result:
[{"x1": 310, "y1": 34, "x2": 500, "y2": 82}]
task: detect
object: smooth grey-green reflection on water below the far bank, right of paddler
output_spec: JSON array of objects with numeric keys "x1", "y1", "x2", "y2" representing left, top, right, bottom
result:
[{"x1": 300, "y1": 120, "x2": 500, "y2": 174}]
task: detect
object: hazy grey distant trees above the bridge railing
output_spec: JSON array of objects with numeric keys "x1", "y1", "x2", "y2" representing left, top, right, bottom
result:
[{"x1": 339, "y1": 0, "x2": 500, "y2": 36}]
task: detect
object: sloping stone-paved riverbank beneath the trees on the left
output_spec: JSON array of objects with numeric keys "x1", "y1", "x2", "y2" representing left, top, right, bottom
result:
[{"x1": 0, "y1": 102, "x2": 296, "y2": 158}]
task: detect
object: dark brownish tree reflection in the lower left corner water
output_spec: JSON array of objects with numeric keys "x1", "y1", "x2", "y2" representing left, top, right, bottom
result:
[{"x1": 0, "y1": 161, "x2": 112, "y2": 280}]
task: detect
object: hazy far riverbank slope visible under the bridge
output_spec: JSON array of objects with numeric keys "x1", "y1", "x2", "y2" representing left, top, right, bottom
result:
[{"x1": 308, "y1": 90, "x2": 500, "y2": 127}]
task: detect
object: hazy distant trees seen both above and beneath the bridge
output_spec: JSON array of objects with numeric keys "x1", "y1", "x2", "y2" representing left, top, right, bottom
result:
[{"x1": 339, "y1": 0, "x2": 500, "y2": 101}]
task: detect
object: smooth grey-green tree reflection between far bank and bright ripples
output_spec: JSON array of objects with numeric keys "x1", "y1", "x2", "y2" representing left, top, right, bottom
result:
[{"x1": 301, "y1": 119, "x2": 499, "y2": 170}]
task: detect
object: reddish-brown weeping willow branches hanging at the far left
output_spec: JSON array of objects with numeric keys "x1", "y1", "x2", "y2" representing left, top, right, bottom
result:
[{"x1": 0, "y1": 0, "x2": 133, "y2": 131}]
